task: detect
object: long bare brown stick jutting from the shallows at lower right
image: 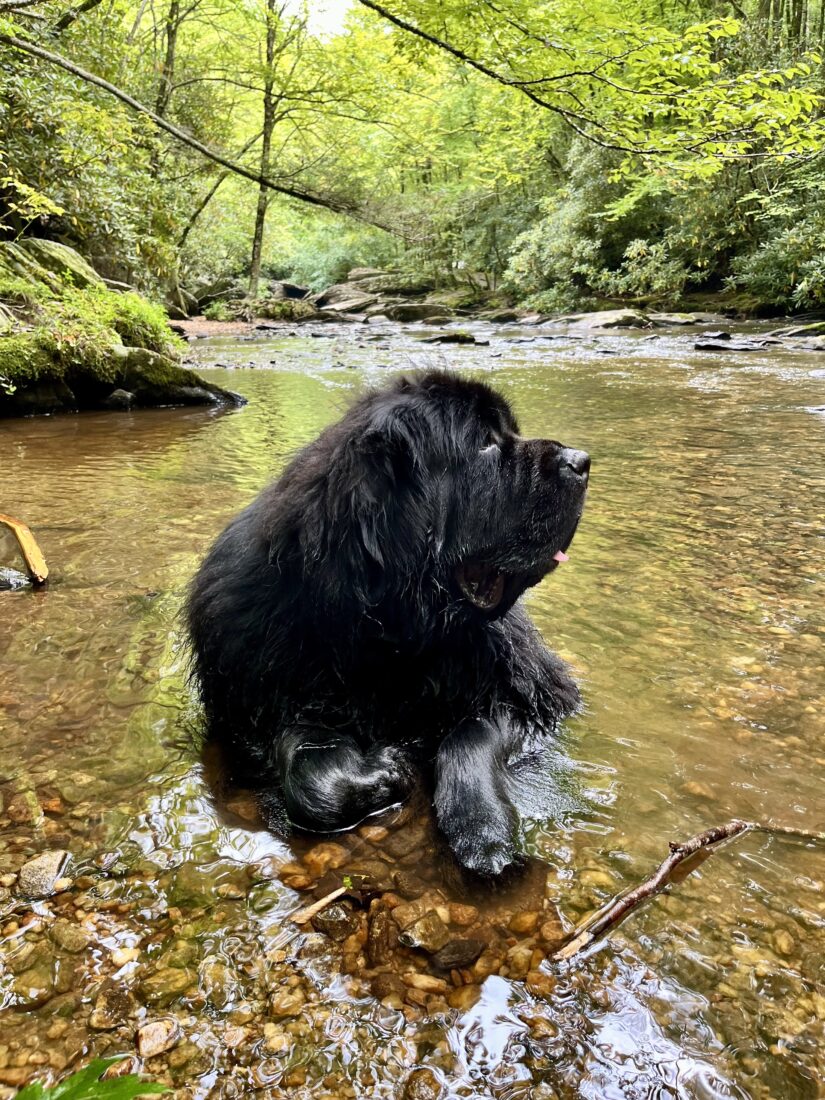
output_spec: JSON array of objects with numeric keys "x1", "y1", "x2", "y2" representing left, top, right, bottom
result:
[{"x1": 550, "y1": 818, "x2": 825, "y2": 963}]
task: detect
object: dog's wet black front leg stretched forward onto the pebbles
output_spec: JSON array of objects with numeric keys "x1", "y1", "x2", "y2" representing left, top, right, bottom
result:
[{"x1": 433, "y1": 718, "x2": 519, "y2": 877}]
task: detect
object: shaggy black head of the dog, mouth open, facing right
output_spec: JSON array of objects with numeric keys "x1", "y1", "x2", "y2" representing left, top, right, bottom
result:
[{"x1": 305, "y1": 372, "x2": 590, "y2": 622}]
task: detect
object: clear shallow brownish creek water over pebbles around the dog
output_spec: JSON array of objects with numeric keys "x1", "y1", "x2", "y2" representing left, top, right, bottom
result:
[{"x1": 0, "y1": 326, "x2": 825, "y2": 1100}]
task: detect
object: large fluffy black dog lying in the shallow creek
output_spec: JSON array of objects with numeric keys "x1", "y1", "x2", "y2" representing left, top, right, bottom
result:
[{"x1": 188, "y1": 372, "x2": 590, "y2": 875}]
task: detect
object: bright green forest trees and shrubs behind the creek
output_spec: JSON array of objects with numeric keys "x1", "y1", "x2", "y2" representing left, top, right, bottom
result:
[{"x1": 0, "y1": 0, "x2": 825, "y2": 310}]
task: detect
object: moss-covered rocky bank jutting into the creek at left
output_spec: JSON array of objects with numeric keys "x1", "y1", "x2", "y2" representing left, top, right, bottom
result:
[{"x1": 0, "y1": 239, "x2": 241, "y2": 416}]
